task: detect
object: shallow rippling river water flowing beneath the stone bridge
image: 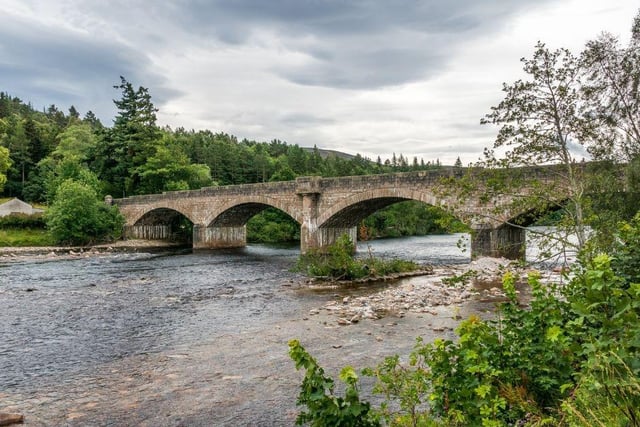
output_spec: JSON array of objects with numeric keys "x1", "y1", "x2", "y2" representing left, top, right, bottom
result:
[{"x1": 0, "y1": 235, "x2": 544, "y2": 426}]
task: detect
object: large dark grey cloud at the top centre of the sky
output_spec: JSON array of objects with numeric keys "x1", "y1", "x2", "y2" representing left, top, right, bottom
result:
[{"x1": 170, "y1": 0, "x2": 552, "y2": 89}]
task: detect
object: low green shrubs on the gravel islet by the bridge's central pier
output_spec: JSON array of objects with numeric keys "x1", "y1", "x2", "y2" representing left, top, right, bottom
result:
[{"x1": 294, "y1": 234, "x2": 420, "y2": 280}]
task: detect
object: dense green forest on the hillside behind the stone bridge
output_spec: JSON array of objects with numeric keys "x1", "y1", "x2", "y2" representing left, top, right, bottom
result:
[{"x1": 0, "y1": 77, "x2": 452, "y2": 242}]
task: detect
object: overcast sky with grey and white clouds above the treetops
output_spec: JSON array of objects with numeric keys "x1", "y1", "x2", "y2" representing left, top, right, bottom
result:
[{"x1": 0, "y1": 0, "x2": 640, "y2": 163}]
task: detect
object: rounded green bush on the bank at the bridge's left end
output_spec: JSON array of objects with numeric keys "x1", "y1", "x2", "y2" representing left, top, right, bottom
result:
[{"x1": 45, "y1": 179, "x2": 124, "y2": 244}]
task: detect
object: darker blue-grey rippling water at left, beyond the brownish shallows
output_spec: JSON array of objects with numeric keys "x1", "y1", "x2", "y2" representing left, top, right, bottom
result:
[{"x1": 0, "y1": 247, "x2": 296, "y2": 390}]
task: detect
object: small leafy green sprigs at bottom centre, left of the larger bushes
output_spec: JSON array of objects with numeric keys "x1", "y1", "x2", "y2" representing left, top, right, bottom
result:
[{"x1": 289, "y1": 340, "x2": 380, "y2": 427}]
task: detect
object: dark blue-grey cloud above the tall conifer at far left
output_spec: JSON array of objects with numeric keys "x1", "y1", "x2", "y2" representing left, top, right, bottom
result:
[{"x1": 0, "y1": 13, "x2": 177, "y2": 124}]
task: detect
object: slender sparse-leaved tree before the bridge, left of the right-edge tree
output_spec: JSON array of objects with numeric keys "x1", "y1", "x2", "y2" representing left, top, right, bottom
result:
[{"x1": 481, "y1": 42, "x2": 594, "y2": 248}]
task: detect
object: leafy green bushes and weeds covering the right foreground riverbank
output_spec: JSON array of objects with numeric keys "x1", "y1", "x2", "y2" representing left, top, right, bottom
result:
[{"x1": 290, "y1": 216, "x2": 640, "y2": 427}]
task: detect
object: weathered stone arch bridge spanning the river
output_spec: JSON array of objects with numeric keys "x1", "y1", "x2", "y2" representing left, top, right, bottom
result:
[{"x1": 112, "y1": 167, "x2": 568, "y2": 259}]
